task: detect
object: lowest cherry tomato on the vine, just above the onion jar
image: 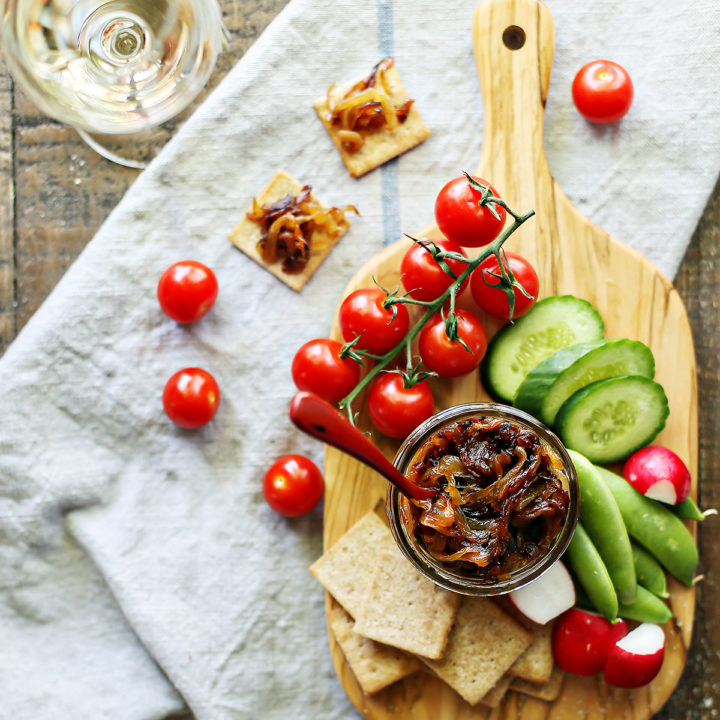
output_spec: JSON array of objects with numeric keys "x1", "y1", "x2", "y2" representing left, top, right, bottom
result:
[{"x1": 368, "y1": 373, "x2": 435, "y2": 438}]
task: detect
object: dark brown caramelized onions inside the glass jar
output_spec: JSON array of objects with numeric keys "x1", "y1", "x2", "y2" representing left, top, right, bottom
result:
[{"x1": 400, "y1": 417, "x2": 569, "y2": 582}]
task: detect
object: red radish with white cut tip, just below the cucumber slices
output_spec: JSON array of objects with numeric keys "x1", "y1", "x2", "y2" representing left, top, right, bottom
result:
[{"x1": 623, "y1": 445, "x2": 691, "y2": 505}]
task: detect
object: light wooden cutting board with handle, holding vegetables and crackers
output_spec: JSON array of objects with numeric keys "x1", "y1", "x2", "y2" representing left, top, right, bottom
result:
[{"x1": 324, "y1": 0, "x2": 698, "y2": 720}]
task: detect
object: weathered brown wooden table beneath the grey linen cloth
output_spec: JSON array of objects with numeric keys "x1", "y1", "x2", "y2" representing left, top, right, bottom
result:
[{"x1": 0, "y1": 0, "x2": 720, "y2": 720}]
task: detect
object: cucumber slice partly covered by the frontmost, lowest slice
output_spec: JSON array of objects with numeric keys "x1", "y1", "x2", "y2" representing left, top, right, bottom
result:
[{"x1": 531, "y1": 340, "x2": 655, "y2": 426}]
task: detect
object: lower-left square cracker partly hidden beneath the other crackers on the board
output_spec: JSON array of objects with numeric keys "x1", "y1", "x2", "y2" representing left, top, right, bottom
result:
[{"x1": 328, "y1": 606, "x2": 420, "y2": 695}]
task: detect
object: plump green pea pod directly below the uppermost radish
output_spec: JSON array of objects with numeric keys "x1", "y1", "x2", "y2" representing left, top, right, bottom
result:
[{"x1": 595, "y1": 467, "x2": 698, "y2": 587}]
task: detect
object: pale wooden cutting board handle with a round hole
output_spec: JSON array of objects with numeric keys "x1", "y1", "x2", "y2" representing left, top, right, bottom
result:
[{"x1": 473, "y1": 0, "x2": 555, "y2": 179}]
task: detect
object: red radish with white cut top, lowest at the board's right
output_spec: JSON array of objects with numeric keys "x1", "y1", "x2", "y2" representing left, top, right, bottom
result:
[{"x1": 605, "y1": 623, "x2": 665, "y2": 688}]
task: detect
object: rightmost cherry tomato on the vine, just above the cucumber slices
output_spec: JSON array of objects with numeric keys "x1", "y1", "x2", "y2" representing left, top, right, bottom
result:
[{"x1": 470, "y1": 252, "x2": 540, "y2": 320}]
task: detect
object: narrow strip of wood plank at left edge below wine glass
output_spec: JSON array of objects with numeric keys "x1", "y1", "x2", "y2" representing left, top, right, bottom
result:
[{"x1": 0, "y1": 59, "x2": 15, "y2": 354}]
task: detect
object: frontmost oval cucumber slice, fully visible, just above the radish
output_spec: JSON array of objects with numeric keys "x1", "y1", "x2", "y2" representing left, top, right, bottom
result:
[{"x1": 555, "y1": 375, "x2": 670, "y2": 463}]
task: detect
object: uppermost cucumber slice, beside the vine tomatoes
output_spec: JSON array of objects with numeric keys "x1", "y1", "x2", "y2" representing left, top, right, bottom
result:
[{"x1": 482, "y1": 295, "x2": 605, "y2": 402}]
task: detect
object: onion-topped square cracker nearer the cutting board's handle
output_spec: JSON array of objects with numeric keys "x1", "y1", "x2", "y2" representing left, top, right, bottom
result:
[{"x1": 314, "y1": 58, "x2": 430, "y2": 177}]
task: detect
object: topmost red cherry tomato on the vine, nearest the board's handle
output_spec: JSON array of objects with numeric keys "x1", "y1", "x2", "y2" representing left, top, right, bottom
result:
[{"x1": 435, "y1": 175, "x2": 505, "y2": 247}]
